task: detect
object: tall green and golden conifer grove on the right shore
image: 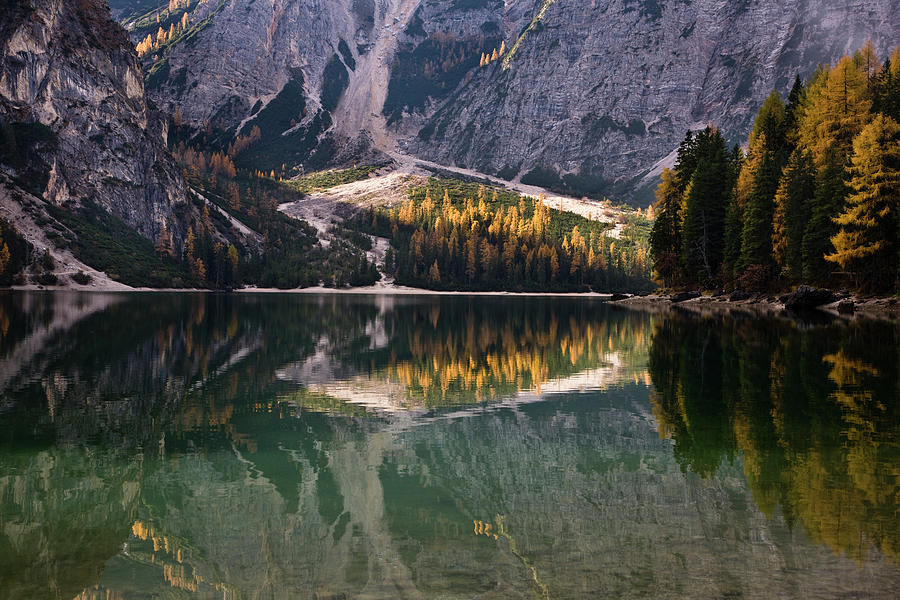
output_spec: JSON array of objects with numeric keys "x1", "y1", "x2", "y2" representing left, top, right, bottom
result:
[{"x1": 650, "y1": 43, "x2": 900, "y2": 291}]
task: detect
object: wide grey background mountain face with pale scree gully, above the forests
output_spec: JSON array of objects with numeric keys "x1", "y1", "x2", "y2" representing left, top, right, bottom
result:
[{"x1": 134, "y1": 0, "x2": 900, "y2": 202}]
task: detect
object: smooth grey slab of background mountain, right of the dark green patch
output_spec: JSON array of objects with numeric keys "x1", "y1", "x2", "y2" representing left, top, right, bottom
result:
[{"x1": 410, "y1": 0, "x2": 900, "y2": 202}]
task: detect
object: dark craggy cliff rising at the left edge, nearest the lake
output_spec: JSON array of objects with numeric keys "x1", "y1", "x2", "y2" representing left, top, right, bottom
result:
[{"x1": 0, "y1": 0, "x2": 187, "y2": 244}]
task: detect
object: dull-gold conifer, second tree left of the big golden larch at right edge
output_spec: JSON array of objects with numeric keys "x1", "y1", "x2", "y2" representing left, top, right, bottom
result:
[{"x1": 772, "y1": 150, "x2": 816, "y2": 281}]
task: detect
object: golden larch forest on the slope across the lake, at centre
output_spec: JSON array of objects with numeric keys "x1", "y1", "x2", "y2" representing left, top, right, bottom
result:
[{"x1": 359, "y1": 179, "x2": 649, "y2": 291}]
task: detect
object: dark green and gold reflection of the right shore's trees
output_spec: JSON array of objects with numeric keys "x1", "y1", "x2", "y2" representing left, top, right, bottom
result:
[{"x1": 649, "y1": 316, "x2": 900, "y2": 563}]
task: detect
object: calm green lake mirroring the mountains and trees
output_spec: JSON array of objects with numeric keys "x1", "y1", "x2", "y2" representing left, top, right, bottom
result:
[{"x1": 0, "y1": 293, "x2": 900, "y2": 600}]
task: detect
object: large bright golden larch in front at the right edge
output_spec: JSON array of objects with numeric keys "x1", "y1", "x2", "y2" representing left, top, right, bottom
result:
[{"x1": 825, "y1": 115, "x2": 900, "y2": 289}]
